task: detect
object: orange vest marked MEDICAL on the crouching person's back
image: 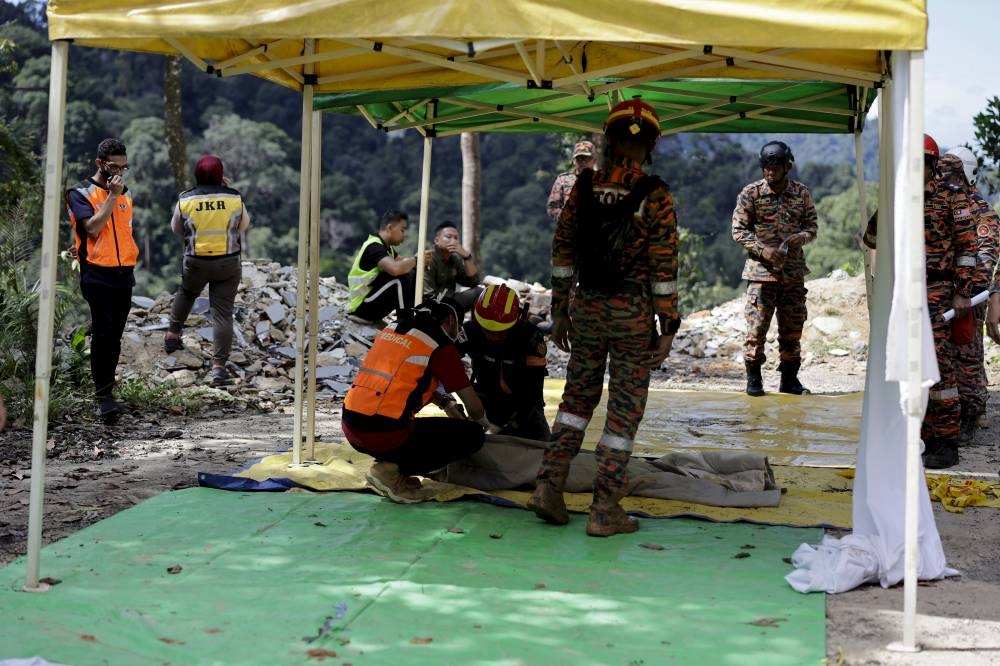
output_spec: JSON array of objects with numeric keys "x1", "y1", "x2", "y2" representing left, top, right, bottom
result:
[{"x1": 344, "y1": 324, "x2": 439, "y2": 427}]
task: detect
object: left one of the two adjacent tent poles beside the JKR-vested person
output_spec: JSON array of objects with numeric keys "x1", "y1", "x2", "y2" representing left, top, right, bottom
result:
[{"x1": 292, "y1": 39, "x2": 315, "y2": 465}]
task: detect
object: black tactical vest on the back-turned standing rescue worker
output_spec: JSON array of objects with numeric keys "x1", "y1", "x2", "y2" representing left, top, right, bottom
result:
[{"x1": 576, "y1": 169, "x2": 664, "y2": 294}]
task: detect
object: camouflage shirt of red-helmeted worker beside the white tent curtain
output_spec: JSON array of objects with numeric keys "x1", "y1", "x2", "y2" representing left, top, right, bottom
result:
[{"x1": 924, "y1": 181, "x2": 977, "y2": 298}]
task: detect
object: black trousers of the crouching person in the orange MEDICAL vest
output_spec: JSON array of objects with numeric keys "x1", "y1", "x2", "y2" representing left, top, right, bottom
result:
[{"x1": 351, "y1": 416, "x2": 486, "y2": 476}]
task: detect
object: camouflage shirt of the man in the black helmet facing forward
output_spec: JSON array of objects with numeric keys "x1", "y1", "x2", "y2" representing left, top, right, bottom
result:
[{"x1": 733, "y1": 178, "x2": 817, "y2": 282}]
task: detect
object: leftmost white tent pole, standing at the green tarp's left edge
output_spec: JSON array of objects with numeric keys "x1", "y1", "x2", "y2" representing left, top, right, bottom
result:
[{"x1": 24, "y1": 41, "x2": 69, "y2": 592}]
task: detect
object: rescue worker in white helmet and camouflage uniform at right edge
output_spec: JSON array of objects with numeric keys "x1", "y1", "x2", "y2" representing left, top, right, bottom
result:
[{"x1": 938, "y1": 146, "x2": 1000, "y2": 444}]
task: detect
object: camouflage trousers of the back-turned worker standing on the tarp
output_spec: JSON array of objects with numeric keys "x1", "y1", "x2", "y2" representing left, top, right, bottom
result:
[{"x1": 538, "y1": 291, "x2": 654, "y2": 498}]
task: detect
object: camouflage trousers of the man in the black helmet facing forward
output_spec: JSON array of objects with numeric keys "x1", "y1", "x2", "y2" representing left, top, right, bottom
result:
[{"x1": 743, "y1": 282, "x2": 809, "y2": 363}]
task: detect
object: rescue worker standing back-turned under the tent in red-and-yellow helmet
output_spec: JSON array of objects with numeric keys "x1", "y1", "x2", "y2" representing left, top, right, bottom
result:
[{"x1": 528, "y1": 99, "x2": 681, "y2": 537}]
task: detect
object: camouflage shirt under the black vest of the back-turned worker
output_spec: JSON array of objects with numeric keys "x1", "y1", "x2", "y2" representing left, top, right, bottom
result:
[{"x1": 552, "y1": 158, "x2": 680, "y2": 320}]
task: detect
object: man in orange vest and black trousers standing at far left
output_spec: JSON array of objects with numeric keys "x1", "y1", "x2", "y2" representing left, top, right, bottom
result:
[{"x1": 66, "y1": 139, "x2": 139, "y2": 425}]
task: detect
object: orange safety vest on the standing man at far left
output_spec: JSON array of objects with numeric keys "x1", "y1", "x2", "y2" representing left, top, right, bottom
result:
[{"x1": 66, "y1": 180, "x2": 139, "y2": 268}]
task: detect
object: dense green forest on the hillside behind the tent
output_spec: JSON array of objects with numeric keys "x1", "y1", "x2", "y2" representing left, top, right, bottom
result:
[{"x1": 0, "y1": 3, "x2": 892, "y2": 310}]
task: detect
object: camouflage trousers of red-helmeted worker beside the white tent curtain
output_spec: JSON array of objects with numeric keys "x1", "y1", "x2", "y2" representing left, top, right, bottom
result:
[{"x1": 920, "y1": 282, "x2": 962, "y2": 443}]
